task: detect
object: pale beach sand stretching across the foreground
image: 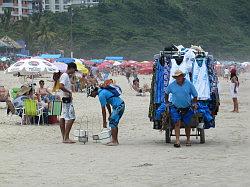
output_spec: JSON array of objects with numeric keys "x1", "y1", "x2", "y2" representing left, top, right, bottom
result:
[{"x1": 0, "y1": 72, "x2": 250, "y2": 187}]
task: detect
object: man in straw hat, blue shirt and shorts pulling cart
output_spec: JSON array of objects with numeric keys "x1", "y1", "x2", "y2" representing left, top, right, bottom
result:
[{"x1": 165, "y1": 70, "x2": 198, "y2": 147}]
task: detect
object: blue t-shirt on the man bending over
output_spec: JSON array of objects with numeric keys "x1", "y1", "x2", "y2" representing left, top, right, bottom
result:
[{"x1": 98, "y1": 88, "x2": 123, "y2": 109}]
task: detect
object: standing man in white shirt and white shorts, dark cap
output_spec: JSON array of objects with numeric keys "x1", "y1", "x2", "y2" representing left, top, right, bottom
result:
[{"x1": 60, "y1": 63, "x2": 77, "y2": 143}]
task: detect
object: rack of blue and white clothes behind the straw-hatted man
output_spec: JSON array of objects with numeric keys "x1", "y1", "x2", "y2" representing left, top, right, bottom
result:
[{"x1": 148, "y1": 45, "x2": 220, "y2": 129}]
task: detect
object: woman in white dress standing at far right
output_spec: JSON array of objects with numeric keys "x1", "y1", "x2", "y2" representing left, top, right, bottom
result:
[{"x1": 230, "y1": 70, "x2": 239, "y2": 113}]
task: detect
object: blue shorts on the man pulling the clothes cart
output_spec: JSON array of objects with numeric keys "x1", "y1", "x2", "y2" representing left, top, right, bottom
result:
[{"x1": 169, "y1": 106, "x2": 194, "y2": 125}]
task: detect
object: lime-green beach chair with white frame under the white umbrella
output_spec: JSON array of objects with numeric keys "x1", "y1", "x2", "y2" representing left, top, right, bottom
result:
[{"x1": 21, "y1": 99, "x2": 44, "y2": 125}]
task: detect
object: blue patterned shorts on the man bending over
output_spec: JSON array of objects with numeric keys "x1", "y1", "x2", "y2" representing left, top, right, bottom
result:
[{"x1": 109, "y1": 103, "x2": 125, "y2": 129}]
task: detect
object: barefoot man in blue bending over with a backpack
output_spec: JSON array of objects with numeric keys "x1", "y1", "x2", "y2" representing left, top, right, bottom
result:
[{"x1": 87, "y1": 85, "x2": 125, "y2": 146}]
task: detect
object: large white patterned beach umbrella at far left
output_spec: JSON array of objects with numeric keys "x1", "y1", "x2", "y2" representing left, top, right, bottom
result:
[{"x1": 5, "y1": 58, "x2": 58, "y2": 75}]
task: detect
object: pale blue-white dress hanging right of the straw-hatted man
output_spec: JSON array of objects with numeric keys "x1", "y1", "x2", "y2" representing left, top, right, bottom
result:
[{"x1": 192, "y1": 58, "x2": 210, "y2": 100}]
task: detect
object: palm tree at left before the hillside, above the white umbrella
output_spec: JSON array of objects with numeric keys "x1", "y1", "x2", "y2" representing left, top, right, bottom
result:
[{"x1": 36, "y1": 23, "x2": 56, "y2": 52}]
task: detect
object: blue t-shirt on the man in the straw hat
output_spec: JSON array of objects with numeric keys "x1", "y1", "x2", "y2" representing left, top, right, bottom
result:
[{"x1": 166, "y1": 79, "x2": 198, "y2": 108}]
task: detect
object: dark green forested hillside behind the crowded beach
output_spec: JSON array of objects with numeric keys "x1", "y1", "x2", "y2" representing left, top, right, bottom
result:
[{"x1": 0, "y1": 0, "x2": 250, "y2": 60}]
